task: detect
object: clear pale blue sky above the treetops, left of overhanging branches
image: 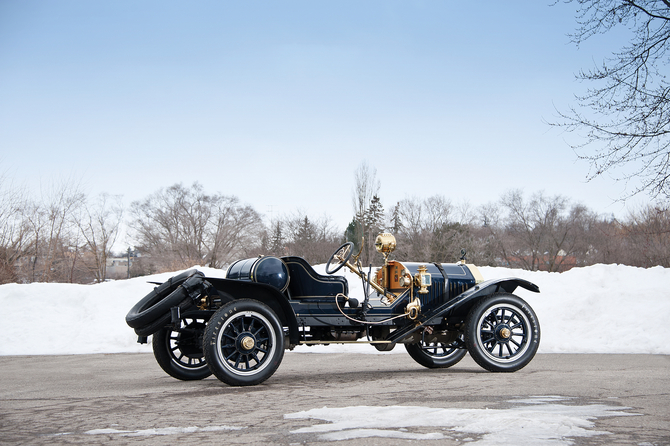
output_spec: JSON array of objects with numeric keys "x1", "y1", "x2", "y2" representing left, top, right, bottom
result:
[{"x1": 0, "y1": 0, "x2": 644, "y2": 228}]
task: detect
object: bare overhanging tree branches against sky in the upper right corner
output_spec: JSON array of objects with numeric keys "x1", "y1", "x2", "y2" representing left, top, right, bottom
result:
[{"x1": 554, "y1": 0, "x2": 670, "y2": 199}]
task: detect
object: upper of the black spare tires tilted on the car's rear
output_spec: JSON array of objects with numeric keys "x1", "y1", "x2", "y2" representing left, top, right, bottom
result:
[{"x1": 126, "y1": 269, "x2": 204, "y2": 334}]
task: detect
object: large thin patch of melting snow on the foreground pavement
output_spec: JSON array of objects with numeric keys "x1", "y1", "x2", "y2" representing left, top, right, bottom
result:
[{"x1": 284, "y1": 396, "x2": 639, "y2": 446}]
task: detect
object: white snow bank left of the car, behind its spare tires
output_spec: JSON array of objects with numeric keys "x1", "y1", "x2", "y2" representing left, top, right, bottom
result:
[{"x1": 0, "y1": 267, "x2": 225, "y2": 355}]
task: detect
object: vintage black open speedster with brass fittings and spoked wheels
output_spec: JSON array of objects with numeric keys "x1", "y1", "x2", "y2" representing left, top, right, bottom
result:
[{"x1": 126, "y1": 233, "x2": 540, "y2": 386}]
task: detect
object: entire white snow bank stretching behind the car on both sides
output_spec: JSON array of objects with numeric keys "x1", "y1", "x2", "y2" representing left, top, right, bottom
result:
[{"x1": 0, "y1": 265, "x2": 670, "y2": 355}]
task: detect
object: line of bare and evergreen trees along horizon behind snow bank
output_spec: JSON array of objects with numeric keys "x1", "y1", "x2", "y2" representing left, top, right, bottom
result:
[{"x1": 0, "y1": 172, "x2": 670, "y2": 283}]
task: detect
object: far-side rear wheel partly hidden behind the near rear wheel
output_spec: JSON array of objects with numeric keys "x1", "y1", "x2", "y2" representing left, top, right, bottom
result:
[{"x1": 152, "y1": 318, "x2": 212, "y2": 381}]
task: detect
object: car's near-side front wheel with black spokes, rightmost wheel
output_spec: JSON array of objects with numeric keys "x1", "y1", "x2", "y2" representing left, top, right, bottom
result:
[{"x1": 465, "y1": 293, "x2": 540, "y2": 372}]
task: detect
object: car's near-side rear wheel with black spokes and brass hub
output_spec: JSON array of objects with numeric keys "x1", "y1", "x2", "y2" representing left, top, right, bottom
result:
[{"x1": 203, "y1": 299, "x2": 284, "y2": 386}]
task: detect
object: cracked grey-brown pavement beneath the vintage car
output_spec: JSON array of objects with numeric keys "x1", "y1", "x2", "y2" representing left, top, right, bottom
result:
[{"x1": 0, "y1": 352, "x2": 670, "y2": 446}]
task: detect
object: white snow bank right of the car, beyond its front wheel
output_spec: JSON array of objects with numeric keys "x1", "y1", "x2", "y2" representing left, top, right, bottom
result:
[{"x1": 480, "y1": 265, "x2": 670, "y2": 354}]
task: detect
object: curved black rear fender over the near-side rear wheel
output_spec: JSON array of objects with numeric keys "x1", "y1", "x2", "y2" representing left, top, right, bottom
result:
[{"x1": 206, "y1": 278, "x2": 300, "y2": 345}]
